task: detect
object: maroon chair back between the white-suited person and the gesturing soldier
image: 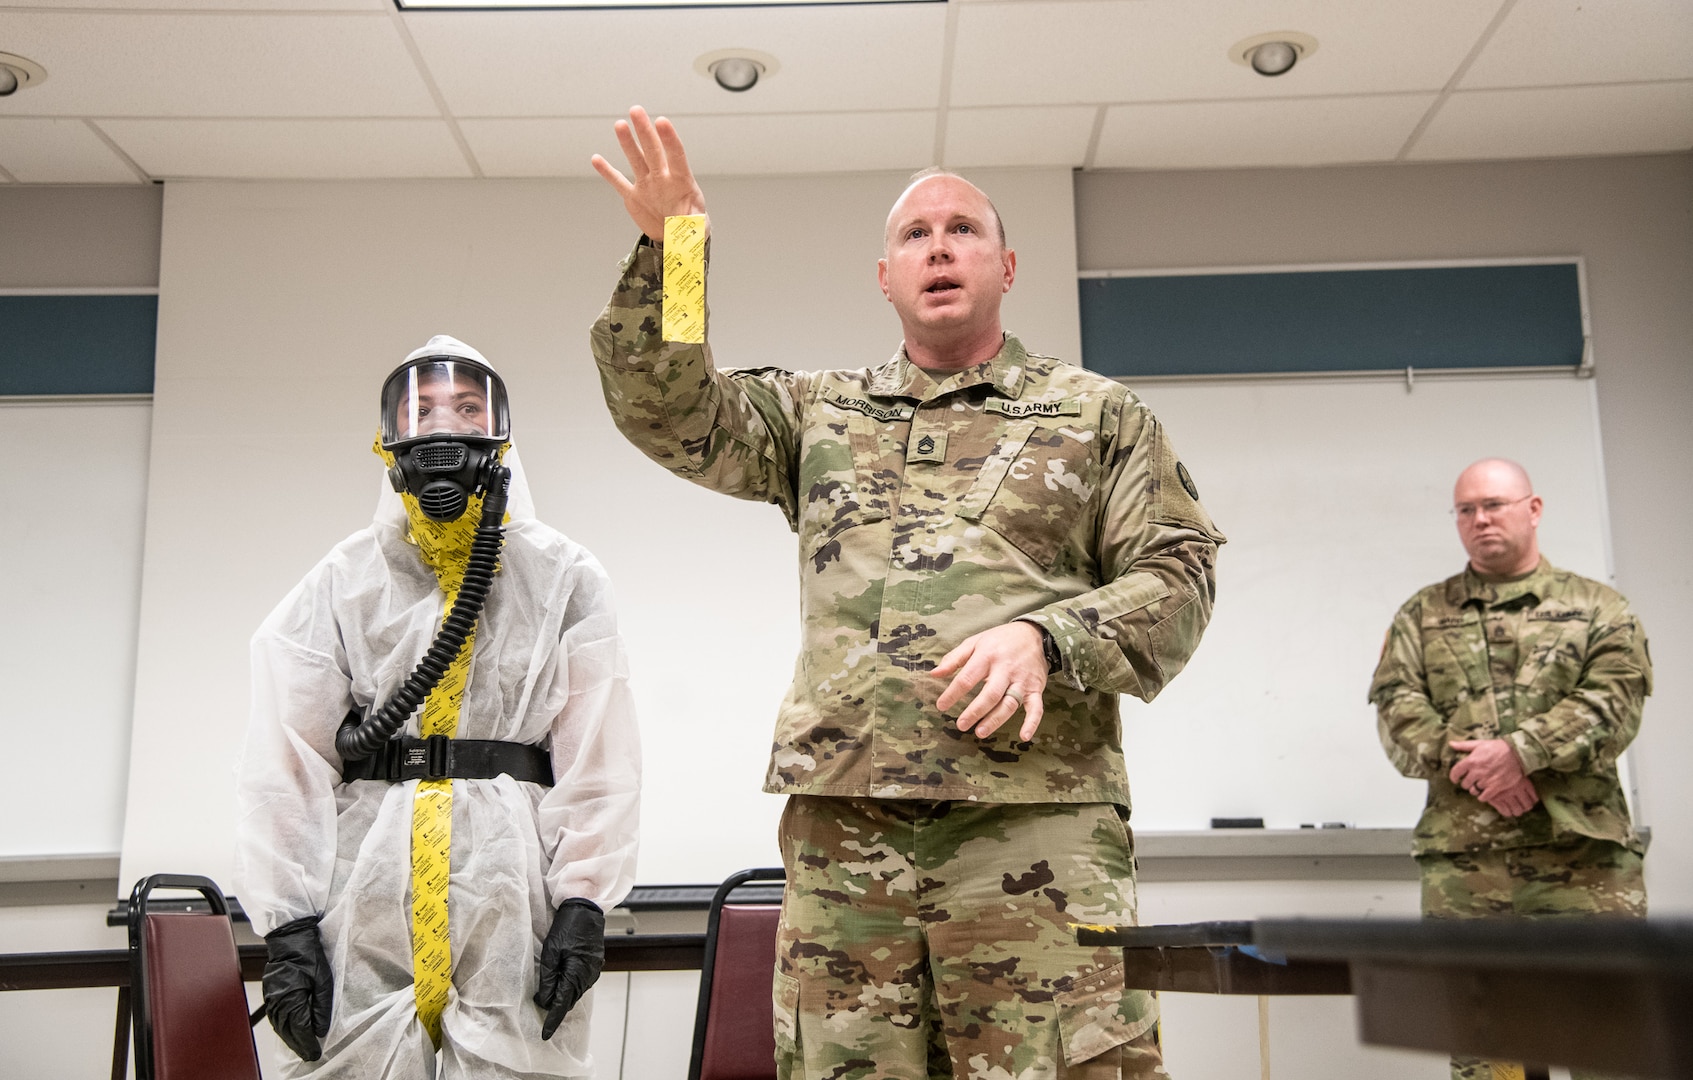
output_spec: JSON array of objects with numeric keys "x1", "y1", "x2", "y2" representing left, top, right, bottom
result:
[{"x1": 687, "y1": 867, "x2": 782, "y2": 1080}]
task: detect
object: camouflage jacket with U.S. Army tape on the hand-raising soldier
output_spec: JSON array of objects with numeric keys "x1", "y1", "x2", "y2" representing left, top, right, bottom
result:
[{"x1": 593, "y1": 244, "x2": 1222, "y2": 806}]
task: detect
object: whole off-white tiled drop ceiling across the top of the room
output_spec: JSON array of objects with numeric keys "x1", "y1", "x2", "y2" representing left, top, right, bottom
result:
[{"x1": 0, "y1": 0, "x2": 1693, "y2": 183}]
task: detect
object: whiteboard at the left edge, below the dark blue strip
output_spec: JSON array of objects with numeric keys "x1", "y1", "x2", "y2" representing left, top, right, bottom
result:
[{"x1": 0, "y1": 398, "x2": 152, "y2": 857}]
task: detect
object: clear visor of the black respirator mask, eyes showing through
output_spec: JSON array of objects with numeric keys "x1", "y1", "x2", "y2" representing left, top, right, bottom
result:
[{"x1": 383, "y1": 357, "x2": 511, "y2": 447}]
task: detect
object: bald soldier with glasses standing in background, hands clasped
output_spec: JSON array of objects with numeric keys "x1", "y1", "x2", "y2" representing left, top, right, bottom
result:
[{"x1": 1370, "y1": 459, "x2": 1652, "y2": 1080}]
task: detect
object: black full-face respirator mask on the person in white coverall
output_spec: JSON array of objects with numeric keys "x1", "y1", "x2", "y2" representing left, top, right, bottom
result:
[{"x1": 383, "y1": 352, "x2": 511, "y2": 521}]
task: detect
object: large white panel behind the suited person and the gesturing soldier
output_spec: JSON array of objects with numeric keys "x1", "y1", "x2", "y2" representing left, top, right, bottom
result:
[{"x1": 122, "y1": 171, "x2": 1078, "y2": 884}]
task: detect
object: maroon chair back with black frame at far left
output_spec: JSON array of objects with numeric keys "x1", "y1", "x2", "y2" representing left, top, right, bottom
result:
[{"x1": 129, "y1": 873, "x2": 259, "y2": 1080}]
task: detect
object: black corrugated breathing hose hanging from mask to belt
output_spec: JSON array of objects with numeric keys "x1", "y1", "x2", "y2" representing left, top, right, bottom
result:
[{"x1": 335, "y1": 466, "x2": 511, "y2": 762}]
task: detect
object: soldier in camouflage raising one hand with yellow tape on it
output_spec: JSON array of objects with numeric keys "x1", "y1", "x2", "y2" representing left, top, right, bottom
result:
[{"x1": 593, "y1": 110, "x2": 1222, "y2": 1080}]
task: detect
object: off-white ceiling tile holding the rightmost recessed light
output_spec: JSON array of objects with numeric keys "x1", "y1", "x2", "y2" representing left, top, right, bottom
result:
[{"x1": 950, "y1": 0, "x2": 1498, "y2": 105}]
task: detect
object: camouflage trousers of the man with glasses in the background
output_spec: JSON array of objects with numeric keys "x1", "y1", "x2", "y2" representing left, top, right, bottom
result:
[{"x1": 1417, "y1": 840, "x2": 1646, "y2": 1080}]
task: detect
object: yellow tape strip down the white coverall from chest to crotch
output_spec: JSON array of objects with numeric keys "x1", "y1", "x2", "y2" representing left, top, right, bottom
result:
[{"x1": 411, "y1": 582, "x2": 476, "y2": 1050}]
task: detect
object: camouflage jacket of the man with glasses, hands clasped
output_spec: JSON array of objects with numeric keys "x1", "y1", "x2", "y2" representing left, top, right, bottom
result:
[{"x1": 1370, "y1": 560, "x2": 1652, "y2": 855}]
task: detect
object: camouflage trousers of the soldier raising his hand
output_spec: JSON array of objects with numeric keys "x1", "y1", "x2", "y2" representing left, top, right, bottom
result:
[{"x1": 774, "y1": 796, "x2": 1168, "y2": 1080}]
